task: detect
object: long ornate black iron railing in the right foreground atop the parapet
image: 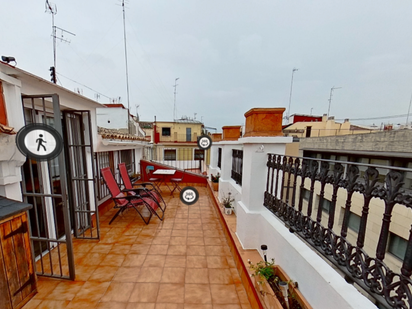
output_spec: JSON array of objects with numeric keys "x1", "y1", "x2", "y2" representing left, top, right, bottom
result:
[{"x1": 264, "y1": 154, "x2": 412, "y2": 308}]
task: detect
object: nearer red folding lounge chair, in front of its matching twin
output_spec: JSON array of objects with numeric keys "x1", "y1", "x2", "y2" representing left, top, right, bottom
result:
[{"x1": 100, "y1": 167, "x2": 163, "y2": 224}]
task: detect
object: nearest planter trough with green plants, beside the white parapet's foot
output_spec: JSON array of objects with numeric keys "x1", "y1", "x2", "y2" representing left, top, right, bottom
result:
[{"x1": 248, "y1": 259, "x2": 312, "y2": 309}]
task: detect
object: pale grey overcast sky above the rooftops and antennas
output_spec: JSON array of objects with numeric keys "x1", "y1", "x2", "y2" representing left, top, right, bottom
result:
[{"x1": 0, "y1": 0, "x2": 412, "y2": 131}]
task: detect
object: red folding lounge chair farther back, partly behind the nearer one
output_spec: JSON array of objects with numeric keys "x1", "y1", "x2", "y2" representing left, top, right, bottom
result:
[{"x1": 119, "y1": 162, "x2": 166, "y2": 213}]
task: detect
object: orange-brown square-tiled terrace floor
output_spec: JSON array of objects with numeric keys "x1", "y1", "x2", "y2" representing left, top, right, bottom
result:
[{"x1": 24, "y1": 187, "x2": 251, "y2": 309}]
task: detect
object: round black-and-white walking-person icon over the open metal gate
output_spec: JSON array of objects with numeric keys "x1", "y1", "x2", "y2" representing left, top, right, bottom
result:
[{"x1": 16, "y1": 123, "x2": 63, "y2": 161}]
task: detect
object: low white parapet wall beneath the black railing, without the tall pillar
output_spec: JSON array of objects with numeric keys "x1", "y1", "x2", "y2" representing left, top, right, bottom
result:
[{"x1": 236, "y1": 202, "x2": 377, "y2": 309}]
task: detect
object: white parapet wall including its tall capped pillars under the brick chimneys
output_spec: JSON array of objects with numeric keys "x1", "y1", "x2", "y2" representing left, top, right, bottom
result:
[{"x1": 211, "y1": 137, "x2": 376, "y2": 309}]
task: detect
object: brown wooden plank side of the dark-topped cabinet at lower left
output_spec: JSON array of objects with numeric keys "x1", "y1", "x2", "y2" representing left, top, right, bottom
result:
[{"x1": 0, "y1": 211, "x2": 37, "y2": 309}]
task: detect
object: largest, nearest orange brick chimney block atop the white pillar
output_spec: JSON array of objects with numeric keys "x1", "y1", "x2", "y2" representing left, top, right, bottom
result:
[{"x1": 243, "y1": 107, "x2": 285, "y2": 137}]
